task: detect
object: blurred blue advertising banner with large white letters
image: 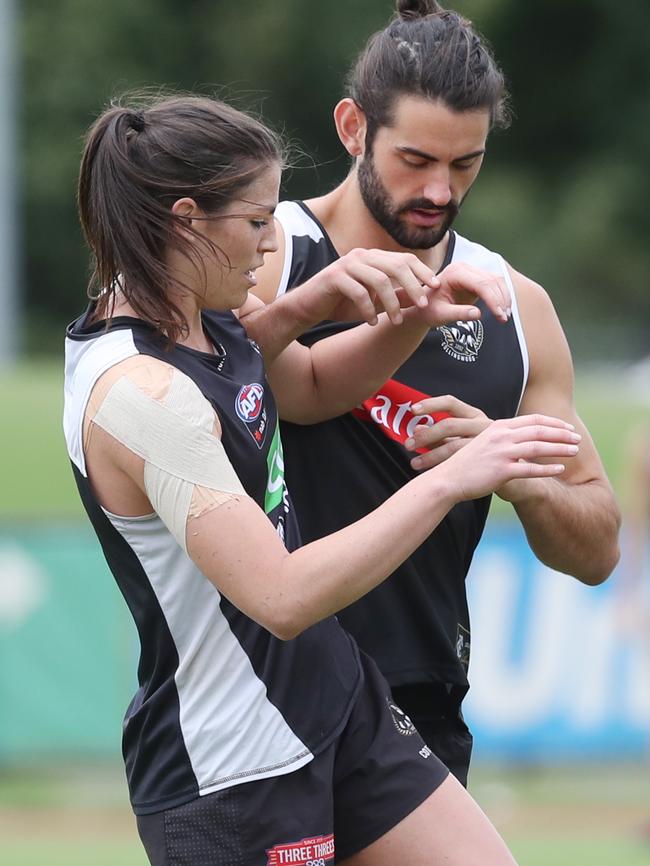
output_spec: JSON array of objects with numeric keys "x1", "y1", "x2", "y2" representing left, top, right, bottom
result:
[{"x1": 465, "y1": 523, "x2": 650, "y2": 761}]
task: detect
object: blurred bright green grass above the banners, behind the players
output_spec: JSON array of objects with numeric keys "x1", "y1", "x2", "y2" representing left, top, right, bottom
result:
[{"x1": 0, "y1": 360, "x2": 650, "y2": 520}]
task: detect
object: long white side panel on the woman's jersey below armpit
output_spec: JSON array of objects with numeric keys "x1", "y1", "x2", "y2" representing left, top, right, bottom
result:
[{"x1": 108, "y1": 514, "x2": 313, "y2": 795}]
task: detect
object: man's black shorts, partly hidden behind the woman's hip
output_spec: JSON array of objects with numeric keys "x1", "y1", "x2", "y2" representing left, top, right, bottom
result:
[{"x1": 393, "y1": 683, "x2": 473, "y2": 787}]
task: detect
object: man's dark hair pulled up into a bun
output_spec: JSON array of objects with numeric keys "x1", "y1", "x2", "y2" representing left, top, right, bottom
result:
[{"x1": 346, "y1": 0, "x2": 510, "y2": 146}]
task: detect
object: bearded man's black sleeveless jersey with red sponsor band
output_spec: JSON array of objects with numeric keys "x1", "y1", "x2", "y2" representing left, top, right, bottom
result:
[{"x1": 275, "y1": 202, "x2": 528, "y2": 700}]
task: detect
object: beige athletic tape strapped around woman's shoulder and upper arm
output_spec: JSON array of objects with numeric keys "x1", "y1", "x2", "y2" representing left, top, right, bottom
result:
[{"x1": 90, "y1": 369, "x2": 246, "y2": 552}]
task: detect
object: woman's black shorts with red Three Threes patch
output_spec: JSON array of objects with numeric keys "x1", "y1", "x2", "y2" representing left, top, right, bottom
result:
[{"x1": 137, "y1": 657, "x2": 448, "y2": 866}]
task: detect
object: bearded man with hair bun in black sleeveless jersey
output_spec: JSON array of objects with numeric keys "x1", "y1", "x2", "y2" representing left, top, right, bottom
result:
[{"x1": 254, "y1": 0, "x2": 620, "y2": 784}]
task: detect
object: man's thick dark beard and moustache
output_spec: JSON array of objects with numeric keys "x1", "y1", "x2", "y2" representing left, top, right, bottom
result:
[{"x1": 357, "y1": 153, "x2": 462, "y2": 250}]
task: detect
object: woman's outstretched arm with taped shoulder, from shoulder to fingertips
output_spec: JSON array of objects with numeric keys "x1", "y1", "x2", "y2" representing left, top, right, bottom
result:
[{"x1": 84, "y1": 359, "x2": 576, "y2": 639}]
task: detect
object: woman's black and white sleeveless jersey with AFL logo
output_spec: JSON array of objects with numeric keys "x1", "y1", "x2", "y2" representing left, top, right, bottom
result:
[{"x1": 64, "y1": 313, "x2": 362, "y2": 814}]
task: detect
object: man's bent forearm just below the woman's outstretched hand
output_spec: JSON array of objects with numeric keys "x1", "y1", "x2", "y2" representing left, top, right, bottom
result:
[{"x1": 508, "y1": 478, "x2": 621, "y2": 585}]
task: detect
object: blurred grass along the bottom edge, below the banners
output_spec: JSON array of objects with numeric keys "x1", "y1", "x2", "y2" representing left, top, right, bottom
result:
[{"x1": 0, "y1": 766, "x2": 650, "y2": 866}]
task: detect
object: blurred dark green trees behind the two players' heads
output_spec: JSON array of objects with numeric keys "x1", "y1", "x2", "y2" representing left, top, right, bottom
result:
[{"x1": 20, "y1": 0, "x2": 650, "y2": 361}]
